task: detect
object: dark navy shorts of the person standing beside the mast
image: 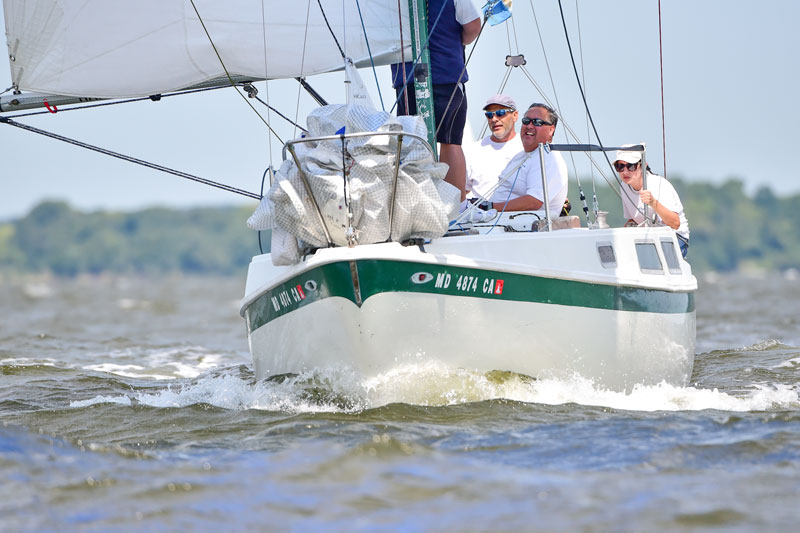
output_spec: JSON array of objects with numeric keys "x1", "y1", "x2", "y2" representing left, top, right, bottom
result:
[{"x1": 395, "y1": 83, "x2": 467, "y2": 145}]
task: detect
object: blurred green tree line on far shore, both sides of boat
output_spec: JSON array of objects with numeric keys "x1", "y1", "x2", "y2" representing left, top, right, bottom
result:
[{"x1": 0, "y1": 179, "x2": 800, "y2": 276}]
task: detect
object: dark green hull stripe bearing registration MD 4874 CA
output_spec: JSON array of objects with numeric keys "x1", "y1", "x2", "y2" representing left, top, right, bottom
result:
[{"x1": 246, "y1": 259, "x2": 694, "y2": 332}]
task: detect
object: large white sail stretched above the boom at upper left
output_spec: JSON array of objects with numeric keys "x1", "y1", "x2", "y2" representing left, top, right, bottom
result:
[{"x1": 3, "y1": 0, "x2": 411, "y2": 98}]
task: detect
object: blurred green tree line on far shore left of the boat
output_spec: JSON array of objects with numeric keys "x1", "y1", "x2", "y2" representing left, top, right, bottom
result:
[{"x1": 0, "y1": 202, "x2": 269, "y2": 276}]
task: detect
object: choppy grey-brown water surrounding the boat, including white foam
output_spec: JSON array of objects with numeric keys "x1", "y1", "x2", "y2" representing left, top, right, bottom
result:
[{"x1": 0, "y1": 272, "x2": 800, "y2": 531}]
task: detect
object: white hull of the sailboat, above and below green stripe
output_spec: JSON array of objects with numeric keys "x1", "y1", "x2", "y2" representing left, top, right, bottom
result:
[{"x1": 242, "y1": 224, "x2": 696, "y2": 389}]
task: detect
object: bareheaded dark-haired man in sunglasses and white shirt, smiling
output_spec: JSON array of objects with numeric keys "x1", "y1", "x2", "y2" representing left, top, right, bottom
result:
[{"x1": 491, "y1": 104, "x2": 567, "y2": 217}]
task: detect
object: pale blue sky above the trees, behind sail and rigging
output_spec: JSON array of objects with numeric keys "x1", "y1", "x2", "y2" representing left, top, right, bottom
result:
[{"x1": 0, "y1": 0, "x2": 800, "y2": 220}]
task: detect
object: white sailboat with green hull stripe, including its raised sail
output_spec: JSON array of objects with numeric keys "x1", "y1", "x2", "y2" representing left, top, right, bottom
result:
[{"x1": 0, "y1": 0, "x2": 697, "y2": 389}]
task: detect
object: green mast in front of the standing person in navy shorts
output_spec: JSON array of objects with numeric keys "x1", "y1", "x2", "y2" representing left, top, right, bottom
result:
[{"x1": 408, "y1": 0, "x2": 438, "y2": 159}]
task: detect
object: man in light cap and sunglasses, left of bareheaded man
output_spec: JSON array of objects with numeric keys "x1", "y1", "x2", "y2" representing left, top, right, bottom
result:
[{"x1": 464, "y1": 94, "x2": 522, "y2": 198}]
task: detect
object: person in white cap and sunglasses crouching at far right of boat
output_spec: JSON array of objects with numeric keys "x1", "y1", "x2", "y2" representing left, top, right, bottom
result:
[{"x1": 614, "y1": 144, "x2": 689, "y2": 258}]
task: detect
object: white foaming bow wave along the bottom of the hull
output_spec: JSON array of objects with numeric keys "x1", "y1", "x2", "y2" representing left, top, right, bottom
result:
[{"x1": 64, "y1": 362, "x2": 800, "y2": 413}]
